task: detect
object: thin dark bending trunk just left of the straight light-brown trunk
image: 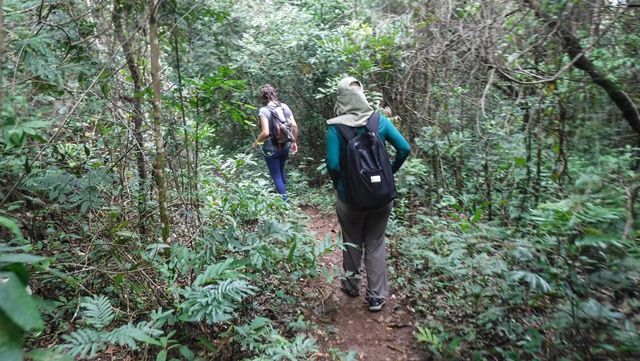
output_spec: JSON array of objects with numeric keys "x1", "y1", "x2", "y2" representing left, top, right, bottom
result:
[{"x1": 113, "y1": 0, "x2": 147, "y2": 234}]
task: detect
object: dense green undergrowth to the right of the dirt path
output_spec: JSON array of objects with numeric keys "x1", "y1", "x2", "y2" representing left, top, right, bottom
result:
[{"x1": 390, "y1": 145, "x2": 640, "y2": 360}]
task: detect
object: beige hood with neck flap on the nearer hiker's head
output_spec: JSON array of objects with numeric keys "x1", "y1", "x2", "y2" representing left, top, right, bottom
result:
[{"x1": 327, "y1": 77, "x2": 373, "y2": 127}]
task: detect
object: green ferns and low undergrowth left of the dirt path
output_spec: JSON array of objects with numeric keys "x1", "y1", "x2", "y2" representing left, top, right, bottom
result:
[{"x1": 0, "y1": 151, "x2": 326, "y2": 361}]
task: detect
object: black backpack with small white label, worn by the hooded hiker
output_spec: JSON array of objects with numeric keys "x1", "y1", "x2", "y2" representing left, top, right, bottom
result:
[{"x1": 336, "y1": 112, "x2": 398, "y2": 210}]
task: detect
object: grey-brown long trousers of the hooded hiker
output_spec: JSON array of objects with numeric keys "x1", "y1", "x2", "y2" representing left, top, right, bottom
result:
[{"x1": 336, "y1": 198, "x2": 393, "y2": 299}]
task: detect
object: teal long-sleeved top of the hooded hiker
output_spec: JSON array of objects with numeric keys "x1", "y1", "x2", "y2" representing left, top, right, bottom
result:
[{"x1": 326, "y1": 114, "x2": 411, "y2": 201}]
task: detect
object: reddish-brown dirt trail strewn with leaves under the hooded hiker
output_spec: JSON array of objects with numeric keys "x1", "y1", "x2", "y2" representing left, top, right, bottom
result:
[{"x1": 303, "y1": 207, "x2": 425, "y2": 361}]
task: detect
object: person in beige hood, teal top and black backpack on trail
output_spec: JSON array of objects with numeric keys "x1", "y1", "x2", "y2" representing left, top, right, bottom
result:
[{"x1": 326, "y1": 77, "x2": 411, "y2": 312}]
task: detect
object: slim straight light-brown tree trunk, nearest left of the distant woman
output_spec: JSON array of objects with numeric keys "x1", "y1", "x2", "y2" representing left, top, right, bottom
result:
[{"x1": 149, "y1": 0, "x2": 171, "y2": 242}]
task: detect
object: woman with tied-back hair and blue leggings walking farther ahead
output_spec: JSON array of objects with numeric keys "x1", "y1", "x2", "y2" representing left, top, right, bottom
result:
[{"x1": 253, "y1": 84, "x2": 298, "y2": 201}]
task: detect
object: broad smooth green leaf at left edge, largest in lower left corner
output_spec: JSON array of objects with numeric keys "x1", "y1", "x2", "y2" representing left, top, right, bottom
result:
[{"x1": 0, "y1": 272, "x2": 44, "y2": 331}]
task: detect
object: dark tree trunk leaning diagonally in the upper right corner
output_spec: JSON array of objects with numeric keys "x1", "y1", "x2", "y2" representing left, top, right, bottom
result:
[{"x1": 524, "y1": 0, "x2": 640, "y2": 134}]
